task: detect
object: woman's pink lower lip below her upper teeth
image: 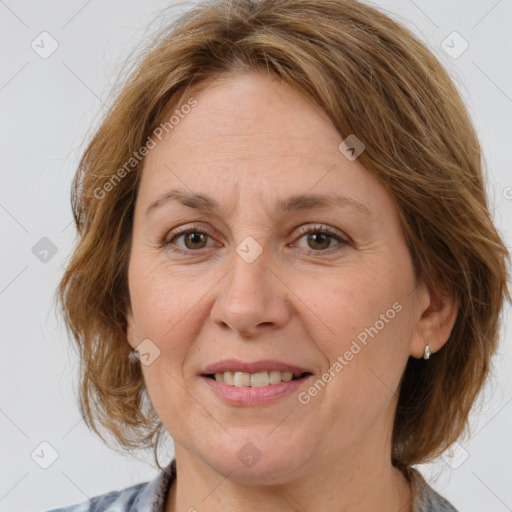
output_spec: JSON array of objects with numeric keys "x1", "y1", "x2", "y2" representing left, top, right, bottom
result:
[{"x1": 201, "y1": 375, "x2": 313, "y2": 407}]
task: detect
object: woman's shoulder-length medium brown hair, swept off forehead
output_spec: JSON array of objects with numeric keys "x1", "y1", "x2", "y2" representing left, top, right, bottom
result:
[{"x1": 58, "y1": 0, "x2": 510, "y2": 472}]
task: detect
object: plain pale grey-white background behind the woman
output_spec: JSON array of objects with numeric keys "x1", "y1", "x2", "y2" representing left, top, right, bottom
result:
[{"x1": 0, "y1": 0, "x2": 512, "y2": 512}]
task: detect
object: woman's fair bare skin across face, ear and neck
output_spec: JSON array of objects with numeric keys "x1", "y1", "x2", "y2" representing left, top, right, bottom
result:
[{"x1": 127, "y1": 72, "x2": 457, "y2": 512}]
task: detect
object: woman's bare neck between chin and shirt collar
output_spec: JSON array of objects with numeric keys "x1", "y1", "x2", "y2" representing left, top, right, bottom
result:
[{"x1": 165, "y1": 443, "x2": 412, "y2": 512}]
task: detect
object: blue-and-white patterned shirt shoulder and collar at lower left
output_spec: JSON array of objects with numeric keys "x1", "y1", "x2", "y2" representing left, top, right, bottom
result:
[{"x1": 42, "y1": 461, "x2": 175, "y2": 512}]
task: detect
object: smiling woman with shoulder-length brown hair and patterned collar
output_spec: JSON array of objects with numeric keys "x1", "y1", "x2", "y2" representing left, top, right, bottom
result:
[{"x1": 48, "y1": 0, "x2": 509, "y2": 512}]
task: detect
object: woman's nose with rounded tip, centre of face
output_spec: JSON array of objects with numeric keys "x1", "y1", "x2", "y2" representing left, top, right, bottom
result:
[{"x1": 210, "y1": 246, "x2": 291, "y2": 338}]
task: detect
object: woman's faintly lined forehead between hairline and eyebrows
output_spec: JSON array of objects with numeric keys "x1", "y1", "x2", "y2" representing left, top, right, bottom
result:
[{"x1": 135, "y1": 73, "x2": 388, "y2": 216}]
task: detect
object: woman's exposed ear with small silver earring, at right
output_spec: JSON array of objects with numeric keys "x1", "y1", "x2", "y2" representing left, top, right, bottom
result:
[{"x1": 410, "y1": 278, "x2": 459, "y2": 359}]
